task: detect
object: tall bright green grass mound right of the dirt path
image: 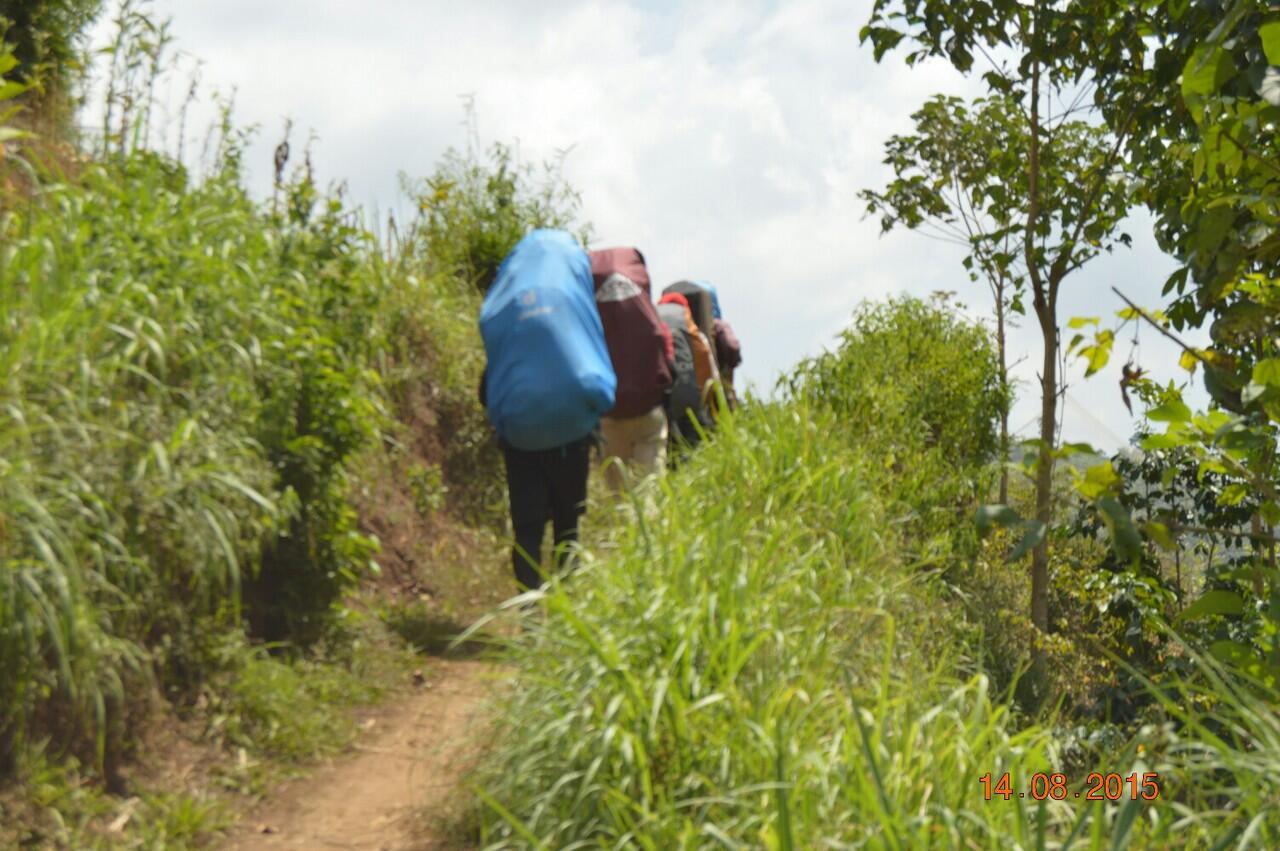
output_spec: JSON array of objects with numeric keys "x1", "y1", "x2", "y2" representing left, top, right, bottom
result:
[{"x1": 476, "y1": 386, "x2": 1277, "y2": 848}]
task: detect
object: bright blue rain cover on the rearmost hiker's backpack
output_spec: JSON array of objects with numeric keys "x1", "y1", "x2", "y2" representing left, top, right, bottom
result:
[{"x1": 480, "y1": 229, "x2": 617, "y2": 450}]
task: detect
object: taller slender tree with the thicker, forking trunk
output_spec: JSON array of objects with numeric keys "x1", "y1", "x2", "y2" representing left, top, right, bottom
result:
[{"x1": 861, "y1": 0, "x2": 1129, "y2": 631}]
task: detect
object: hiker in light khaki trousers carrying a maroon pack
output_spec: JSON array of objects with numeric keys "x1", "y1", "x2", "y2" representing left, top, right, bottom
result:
[{"x1": 591, "y1": 248, "x2": 675, "y2": 493}]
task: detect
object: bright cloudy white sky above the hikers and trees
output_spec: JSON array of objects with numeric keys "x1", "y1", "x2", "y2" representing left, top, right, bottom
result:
[{"x1": 91, "y1": 0, "x2": 1204, "y2": 449}]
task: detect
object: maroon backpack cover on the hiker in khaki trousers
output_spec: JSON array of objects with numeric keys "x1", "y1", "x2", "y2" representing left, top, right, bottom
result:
[{"x1": 591, "y1": 248, "x2": 671, "y2": 417}]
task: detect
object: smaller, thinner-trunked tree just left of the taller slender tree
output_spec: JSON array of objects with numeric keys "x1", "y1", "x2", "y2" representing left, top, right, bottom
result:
[{"x1": 859, "y1": 96, "x2": 1025, "y2": 504}]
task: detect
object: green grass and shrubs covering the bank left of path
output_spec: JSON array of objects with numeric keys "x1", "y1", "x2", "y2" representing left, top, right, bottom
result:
[{"x1": 0, "y1": 24, "x2": 588, "y2": 775}]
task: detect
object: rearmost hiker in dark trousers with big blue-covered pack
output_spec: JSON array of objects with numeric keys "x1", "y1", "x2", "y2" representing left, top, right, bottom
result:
[{"x1": 480, "y1": 229, "x2": 617, "y2": 590}]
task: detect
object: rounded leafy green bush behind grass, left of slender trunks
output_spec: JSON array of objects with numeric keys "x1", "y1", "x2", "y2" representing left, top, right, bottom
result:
[{"x1": 785, "y1": 297, "x2": 1009, "y2": 564}]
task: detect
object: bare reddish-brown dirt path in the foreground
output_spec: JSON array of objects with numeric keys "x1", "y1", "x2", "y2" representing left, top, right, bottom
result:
[{"x1": 220, "y1": 659, "x2": 493, "y2": 851}]
